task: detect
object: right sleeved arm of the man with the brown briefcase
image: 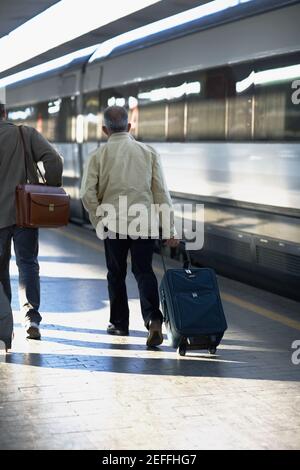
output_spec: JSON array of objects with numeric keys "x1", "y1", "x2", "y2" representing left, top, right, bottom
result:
[{"x1": 30, "y1": 128, "x2": 63, "y2": 186}]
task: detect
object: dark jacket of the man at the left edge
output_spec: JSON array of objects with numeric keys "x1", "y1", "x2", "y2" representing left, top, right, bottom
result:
[{"x1": 0, "y1": 120, "x2": 63, "y2": 229}]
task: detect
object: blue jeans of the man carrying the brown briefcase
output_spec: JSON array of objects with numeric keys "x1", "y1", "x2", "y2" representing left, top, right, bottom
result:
[{"x1": 0, "y1": 226, "x2": 42, "y2": 323}]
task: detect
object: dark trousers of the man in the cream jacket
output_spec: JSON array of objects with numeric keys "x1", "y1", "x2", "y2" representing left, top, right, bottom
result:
[{"x1": 104, "y1": 238, "x2": 163, "y2": 330}]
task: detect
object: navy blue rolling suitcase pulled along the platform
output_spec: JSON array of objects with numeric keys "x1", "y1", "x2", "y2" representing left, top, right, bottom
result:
[{"x1": 160, "y1": 248, "x2": 227, "y2": 356}]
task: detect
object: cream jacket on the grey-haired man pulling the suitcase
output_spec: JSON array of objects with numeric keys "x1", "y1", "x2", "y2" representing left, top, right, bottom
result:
[{"x1": 80, "y1": 132, "x2": 175, "y2": 238}]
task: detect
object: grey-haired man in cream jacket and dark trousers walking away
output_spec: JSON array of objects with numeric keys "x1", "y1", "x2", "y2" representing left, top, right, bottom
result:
[{"x1": 81, "y1": 106, "x2": 178, "y2": 347}]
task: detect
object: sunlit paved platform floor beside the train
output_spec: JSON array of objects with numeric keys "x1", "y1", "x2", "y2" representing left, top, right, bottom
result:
[{"x1": 0, "y1": 226, "x2": 300, "y2": 450}]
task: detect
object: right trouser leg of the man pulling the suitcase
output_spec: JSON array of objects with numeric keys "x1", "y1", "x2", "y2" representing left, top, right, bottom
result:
[{"x1": 130, "y1": 239, "x2": 163, "y2": 327}]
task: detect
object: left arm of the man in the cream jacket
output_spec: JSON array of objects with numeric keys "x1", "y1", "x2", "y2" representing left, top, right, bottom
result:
[{"x1": 80, "y1": 151, "x2": 99, "y2": 228}]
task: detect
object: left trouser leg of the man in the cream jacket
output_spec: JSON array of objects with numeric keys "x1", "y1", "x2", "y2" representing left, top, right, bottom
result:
[{"x1": 104, "y1": 238, "x2": 129, "y2": 330}]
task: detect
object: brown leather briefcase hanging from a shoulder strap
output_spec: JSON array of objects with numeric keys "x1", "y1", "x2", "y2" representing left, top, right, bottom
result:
[{"x1": 16, "y1": 127, "x2": 70, "y2": 228}]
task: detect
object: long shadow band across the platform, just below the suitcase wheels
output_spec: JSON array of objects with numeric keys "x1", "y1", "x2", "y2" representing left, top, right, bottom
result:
[{"x1": 4, "y1": 343, "x2": 300, "y2": 382}]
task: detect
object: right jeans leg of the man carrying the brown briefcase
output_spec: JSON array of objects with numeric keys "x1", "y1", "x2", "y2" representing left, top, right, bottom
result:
[{"x1": 13, "y1": 227, "x2": 42, "y2": 324}]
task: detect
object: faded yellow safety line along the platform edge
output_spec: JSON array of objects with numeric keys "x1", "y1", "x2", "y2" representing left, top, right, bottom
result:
[{"x1": 56, "y1": 230, "x2": 300, "y2": 331}]
